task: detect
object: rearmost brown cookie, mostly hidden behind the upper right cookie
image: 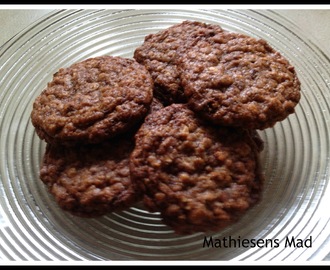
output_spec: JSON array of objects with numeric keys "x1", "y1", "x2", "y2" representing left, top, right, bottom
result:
[{"x1": 134, "y1": 21, "x2": 222, "y2": 105}]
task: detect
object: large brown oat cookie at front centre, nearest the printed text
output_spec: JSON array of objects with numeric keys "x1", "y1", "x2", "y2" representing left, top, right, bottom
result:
[{"x1": 130, "y1": 104, "x2": 263, "y2": 234}]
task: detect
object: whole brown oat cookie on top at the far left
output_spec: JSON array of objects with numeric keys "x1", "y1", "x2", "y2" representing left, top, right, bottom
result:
[{"x1": 31, "y1": 55, "x2": 153, "y2": 144}]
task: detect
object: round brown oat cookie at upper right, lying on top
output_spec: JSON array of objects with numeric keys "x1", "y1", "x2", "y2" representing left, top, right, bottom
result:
[{"x1": 177, "y1": 31, "x2": 300, "y2": 129}]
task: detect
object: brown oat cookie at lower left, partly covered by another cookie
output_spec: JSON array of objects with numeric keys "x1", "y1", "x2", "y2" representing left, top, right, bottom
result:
[{"x1": 40, "y1": 137, "x2": 140, "y2": 218}]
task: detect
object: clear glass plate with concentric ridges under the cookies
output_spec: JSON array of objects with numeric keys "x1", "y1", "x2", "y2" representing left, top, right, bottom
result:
[{"x1": 0, "y1": 9, "x2": 330, "y2": 261}]
